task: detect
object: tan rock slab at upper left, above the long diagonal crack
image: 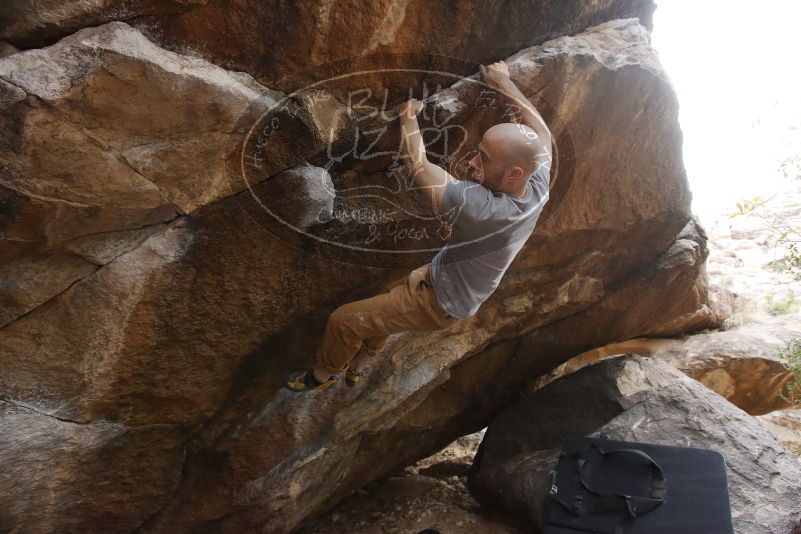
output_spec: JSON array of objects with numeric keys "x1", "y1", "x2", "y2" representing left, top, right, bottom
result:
[{"x1": 0, "y1": 22, "x2": 334, "y2": 326}]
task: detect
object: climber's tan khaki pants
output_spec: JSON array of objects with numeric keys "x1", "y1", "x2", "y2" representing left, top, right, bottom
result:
[{"x1": 316, "y1": 263, "x2": 459, "y2": 373}]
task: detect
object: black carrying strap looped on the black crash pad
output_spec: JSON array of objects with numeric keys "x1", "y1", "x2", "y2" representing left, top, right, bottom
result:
[{"x1": 568, "y1": 443, "x2": 665, "y2": 517}]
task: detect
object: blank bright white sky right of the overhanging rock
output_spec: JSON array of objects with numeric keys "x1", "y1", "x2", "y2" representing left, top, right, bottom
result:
[{"x1": 651, "y1": 0, "x2": 801, "y2": 220}]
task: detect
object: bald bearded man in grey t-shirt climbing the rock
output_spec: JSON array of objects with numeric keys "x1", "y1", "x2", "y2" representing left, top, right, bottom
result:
[{"x1": 285, "y1": 61, "x2": 552, "y2": 391}]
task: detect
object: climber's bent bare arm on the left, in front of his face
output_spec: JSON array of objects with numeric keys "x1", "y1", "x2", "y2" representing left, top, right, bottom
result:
[{"x1": 398, "y1": 99, "x2": 456, "y2": 213}]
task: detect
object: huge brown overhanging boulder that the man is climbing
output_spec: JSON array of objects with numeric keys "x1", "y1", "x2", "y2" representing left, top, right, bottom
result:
[{"x1": 0, "y1": 12, "x2": 715, "y2": 532}]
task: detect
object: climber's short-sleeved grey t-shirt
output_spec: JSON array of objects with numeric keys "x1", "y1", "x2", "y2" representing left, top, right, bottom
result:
[{"x1": 430, "y1": 166, "x2": 551, "y2": 319}]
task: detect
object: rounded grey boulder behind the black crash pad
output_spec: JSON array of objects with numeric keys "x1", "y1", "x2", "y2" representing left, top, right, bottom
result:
[{"x1": 468, "y1": 354, "x2": 801, "y2": 534}]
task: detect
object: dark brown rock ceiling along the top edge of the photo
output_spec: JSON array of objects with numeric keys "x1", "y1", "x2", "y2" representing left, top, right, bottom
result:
[{"x1": 0, "y1": 0, "x2": 656, "y2": 90}]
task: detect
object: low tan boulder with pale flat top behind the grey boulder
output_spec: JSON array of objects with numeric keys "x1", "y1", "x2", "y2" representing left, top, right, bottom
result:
[{"x1": 538, "y1": 314, "x2": 801, "y2": 415}]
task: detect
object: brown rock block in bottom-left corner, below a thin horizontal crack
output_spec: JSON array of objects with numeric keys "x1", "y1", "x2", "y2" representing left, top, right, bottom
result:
[{"x1": 0, "y1": 400, "x2": 185, "y2": 532}]
